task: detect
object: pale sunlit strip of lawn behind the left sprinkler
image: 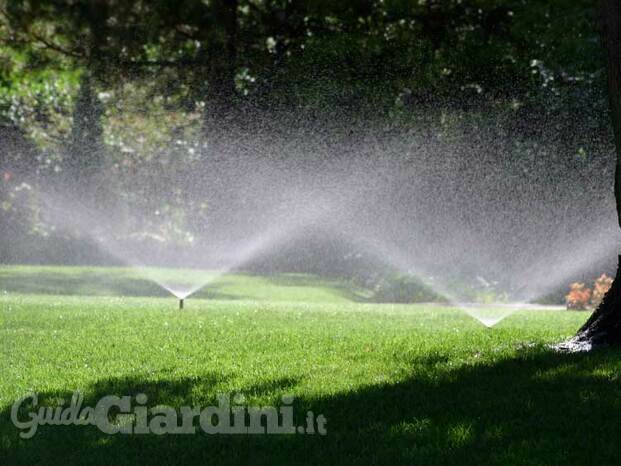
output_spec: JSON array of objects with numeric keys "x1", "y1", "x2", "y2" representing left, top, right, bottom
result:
[{"x1": 0, "y1": 265, "x2": 371, "y2": 303}]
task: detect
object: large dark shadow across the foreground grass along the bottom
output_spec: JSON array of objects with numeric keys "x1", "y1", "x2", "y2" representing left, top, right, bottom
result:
[{"x1": 2, "y1": 350, "x2": 621, "y2": 466}]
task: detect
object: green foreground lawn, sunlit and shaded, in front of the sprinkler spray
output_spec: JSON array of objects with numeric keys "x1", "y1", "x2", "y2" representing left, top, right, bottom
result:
[{"x1": 0, "y1": 271, "x2": 621, "y2": 465}]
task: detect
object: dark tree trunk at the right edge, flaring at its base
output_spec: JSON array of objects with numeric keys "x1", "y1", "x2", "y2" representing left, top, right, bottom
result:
[{"x1": 560, "y1": 0, "x2": 621, "y2": 349}]
